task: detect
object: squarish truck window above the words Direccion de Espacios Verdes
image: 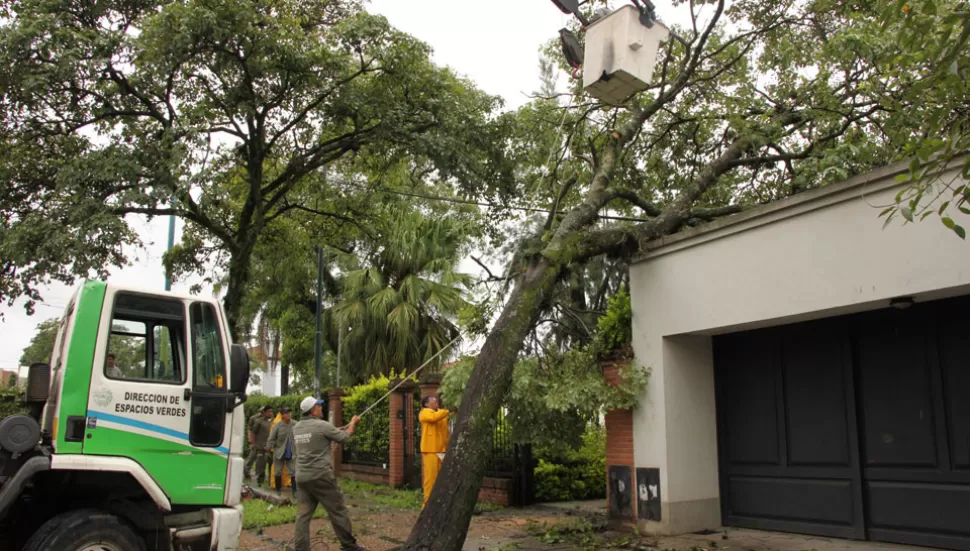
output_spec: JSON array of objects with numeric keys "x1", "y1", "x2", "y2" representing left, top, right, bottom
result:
[{"x1": 104, "y1": 293, "x2": 185, "y2": 384}]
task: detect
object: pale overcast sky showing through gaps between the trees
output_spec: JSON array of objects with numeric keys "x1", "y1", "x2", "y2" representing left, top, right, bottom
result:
[{"x1": 0, "y1": 0, "x2": 689, "y2": 376}]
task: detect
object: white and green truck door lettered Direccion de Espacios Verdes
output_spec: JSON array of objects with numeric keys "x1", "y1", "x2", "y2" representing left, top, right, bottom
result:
[{"x1": 83, "y1": 292, "x2": 228, "y2": 505}]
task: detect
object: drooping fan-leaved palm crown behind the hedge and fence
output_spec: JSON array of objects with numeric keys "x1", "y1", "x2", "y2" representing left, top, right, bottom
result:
[{"x1": 327, "y1": 212, "x2": 472, "y2": 380}]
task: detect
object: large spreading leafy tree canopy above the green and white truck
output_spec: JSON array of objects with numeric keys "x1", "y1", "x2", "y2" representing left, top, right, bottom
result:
[{"x1": 0, "y1": 0, "x2": 503, "y2": 335}]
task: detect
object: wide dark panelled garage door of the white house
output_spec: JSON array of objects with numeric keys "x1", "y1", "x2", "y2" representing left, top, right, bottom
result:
[{"x1": 714, "y1": 297, "x2": 970, "y2": 550}]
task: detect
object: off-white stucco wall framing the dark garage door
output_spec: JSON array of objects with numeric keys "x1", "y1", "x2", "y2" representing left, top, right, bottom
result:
[{"x1": 630, "y1": 160, "x2": 970, "y2": 533}]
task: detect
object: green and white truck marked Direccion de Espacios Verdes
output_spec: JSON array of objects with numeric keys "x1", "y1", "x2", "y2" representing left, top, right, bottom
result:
[{"x1": 0, "y1": 280, "x2": 249, "y2": 551}]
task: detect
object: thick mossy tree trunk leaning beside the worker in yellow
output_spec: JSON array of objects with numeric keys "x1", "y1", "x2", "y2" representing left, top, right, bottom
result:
[{"x1": 403, "y1": 258, "x2": 562, "y2": 551}]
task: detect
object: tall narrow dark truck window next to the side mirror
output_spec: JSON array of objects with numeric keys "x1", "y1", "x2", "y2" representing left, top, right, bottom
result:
[{"x1": 189, "y1": 302, "x2": 231, "y2": 446}]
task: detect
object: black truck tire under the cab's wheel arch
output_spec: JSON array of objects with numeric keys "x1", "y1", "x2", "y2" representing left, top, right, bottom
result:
[{"x1": 23, "y1": 509, "x2": 145, "y2": 551}]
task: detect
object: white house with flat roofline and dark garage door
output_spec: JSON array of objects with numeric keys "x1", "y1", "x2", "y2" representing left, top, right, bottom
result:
[{"x1": 610, "y1": 157, "x2": 970, "y2": 550}]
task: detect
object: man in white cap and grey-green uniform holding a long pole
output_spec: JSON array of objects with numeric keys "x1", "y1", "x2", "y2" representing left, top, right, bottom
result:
[{"x1": 293, "y1": 397, "x2": 363, "y2": 551}]
